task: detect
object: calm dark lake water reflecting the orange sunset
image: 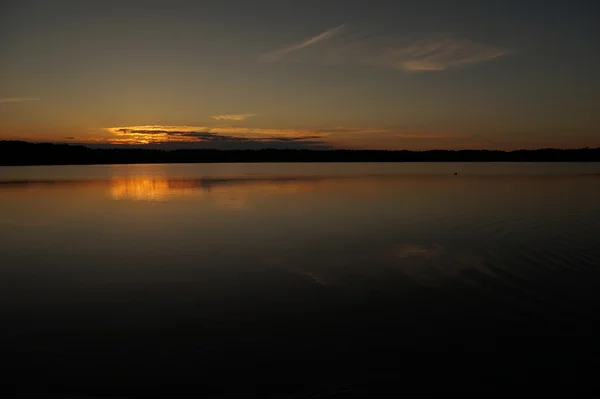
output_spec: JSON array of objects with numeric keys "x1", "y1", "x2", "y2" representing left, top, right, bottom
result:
[{"x1": 0, "y1": 164, "x2": 600, "y2": 397}]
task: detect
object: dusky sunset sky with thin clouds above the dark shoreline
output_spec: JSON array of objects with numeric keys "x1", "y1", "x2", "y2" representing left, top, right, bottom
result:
[{"x1": 0, "y1": 0, "x2": 600, "y2": 150}]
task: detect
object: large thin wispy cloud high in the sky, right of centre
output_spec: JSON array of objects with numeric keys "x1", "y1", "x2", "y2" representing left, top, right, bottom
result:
[{"x1": 261, "y1": 25, "x2": 510, "y2": 72}]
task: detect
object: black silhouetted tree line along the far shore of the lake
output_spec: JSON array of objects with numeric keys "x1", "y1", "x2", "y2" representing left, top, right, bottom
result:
[{"x1": 0, "y1": 141, "x2": 600, "y2": 165}]
